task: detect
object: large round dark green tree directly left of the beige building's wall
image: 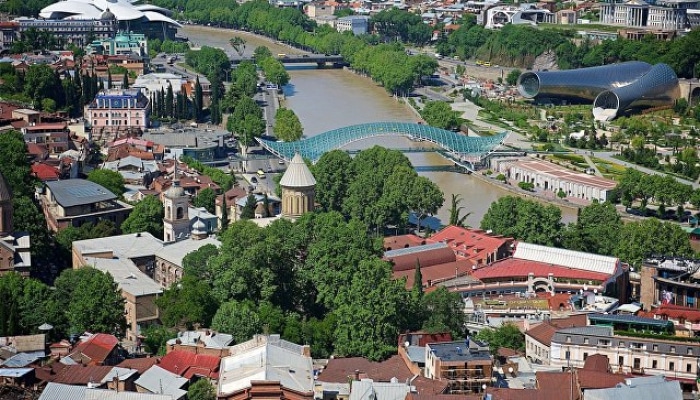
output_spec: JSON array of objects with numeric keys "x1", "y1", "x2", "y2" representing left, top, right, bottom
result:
[{"x1": 55, "y1": 267, "x2": 126, "y2": 336}]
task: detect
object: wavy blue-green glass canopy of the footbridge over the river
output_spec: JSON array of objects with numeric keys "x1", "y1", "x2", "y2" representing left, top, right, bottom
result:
[{"x1": 255, "y1": 122, "x2": 506, "y2": 162}]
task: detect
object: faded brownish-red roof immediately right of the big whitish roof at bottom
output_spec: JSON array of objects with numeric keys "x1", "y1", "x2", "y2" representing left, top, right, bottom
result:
[{"x1": 318, "y1": 355, "x2": 413, "y2": 383}]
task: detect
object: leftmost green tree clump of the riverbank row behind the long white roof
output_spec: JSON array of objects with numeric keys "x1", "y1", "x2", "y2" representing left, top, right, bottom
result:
[{"x1": 481, "y1": 196, "x2": 561, "y2": 246}]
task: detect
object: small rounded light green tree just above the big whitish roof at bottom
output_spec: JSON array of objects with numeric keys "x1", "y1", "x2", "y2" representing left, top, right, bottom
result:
[{"x1": 211, "y1": 300, "x2": 262, "y2": 343}]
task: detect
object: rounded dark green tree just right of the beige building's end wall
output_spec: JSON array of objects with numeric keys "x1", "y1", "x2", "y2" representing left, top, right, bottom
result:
[{"x1": 156, "y1": 275, "x2": 217, "y2": 329}]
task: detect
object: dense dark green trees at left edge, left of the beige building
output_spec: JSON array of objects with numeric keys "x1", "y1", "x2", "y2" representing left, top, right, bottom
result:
[{"x1": 0, "y1": 268, "x2": 126, "y2": 337}]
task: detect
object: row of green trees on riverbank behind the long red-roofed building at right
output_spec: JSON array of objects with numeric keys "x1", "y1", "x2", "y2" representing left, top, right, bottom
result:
[{"x1": 481, "y1": 195, "x2": 693, "y2": 265}]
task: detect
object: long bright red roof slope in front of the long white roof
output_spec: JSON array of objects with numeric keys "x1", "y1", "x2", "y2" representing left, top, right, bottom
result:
[{"x1": 472, "y1": 258, "x2": 610, "y2": 281}]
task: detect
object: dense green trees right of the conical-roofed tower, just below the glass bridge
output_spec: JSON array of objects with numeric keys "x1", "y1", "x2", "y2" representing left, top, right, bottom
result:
[{"x1": 313, "y1": 146, "x2": 444, "y2": 231}]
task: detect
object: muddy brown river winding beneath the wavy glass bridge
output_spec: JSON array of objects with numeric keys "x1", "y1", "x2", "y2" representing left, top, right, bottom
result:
[{"x1": 184, "y1": 25, "x2": 576, "y2": 227}]
